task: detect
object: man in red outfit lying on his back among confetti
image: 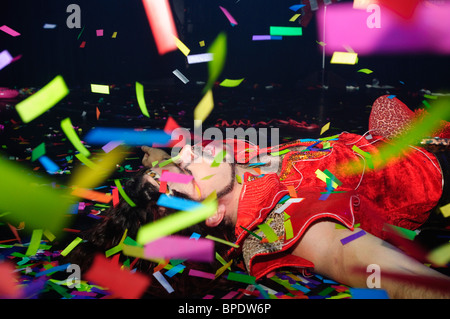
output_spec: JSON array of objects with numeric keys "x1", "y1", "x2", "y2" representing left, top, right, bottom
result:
[{"x1": 67, "y1": 97, "x2": 450, "y2": 298}]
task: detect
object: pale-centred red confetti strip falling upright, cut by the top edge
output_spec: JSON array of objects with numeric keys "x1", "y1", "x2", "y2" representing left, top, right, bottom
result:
[{"x1": 142, "y1": 0, "x2": 178, "y2": 55}]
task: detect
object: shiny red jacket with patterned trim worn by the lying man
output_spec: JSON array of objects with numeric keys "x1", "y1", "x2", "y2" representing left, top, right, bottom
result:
[{"x1": 225, "y1": 133, "x2": 443, "y2": 278}]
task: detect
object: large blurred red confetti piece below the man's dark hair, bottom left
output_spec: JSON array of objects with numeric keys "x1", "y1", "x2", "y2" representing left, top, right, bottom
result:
[{"x1": 84, "y1": 255, "x2": 150, "y2": 299}]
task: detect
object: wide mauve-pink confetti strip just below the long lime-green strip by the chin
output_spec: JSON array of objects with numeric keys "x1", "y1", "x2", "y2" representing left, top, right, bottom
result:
[{"x1": 144, "y1": 236, "x2": 214, "y2": 262}]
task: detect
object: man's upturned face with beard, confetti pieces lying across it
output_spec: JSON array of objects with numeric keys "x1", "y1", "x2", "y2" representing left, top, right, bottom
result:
[{"x1": 146, "y1": 142, "x2": 236, "y2": 201}]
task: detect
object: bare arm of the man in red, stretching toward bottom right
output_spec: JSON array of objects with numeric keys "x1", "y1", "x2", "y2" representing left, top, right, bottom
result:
[{"x1": 292, "y1": 221, "x2": 450, "y2": 299}]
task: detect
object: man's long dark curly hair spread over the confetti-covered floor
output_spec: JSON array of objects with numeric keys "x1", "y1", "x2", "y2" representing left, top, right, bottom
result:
[{"x1": 65, "y1": 168, "x2": 239, "y2": 298}]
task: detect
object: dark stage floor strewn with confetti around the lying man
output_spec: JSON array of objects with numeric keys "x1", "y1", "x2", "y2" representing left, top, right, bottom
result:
[{"x1": 0, "y1": 81, "x2": 449, "y2": 299}]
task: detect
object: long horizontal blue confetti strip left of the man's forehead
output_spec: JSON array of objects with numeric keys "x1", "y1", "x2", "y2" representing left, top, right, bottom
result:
[{"x1": 84, "y1": 127, "x2": 171, "y2": 146}]
